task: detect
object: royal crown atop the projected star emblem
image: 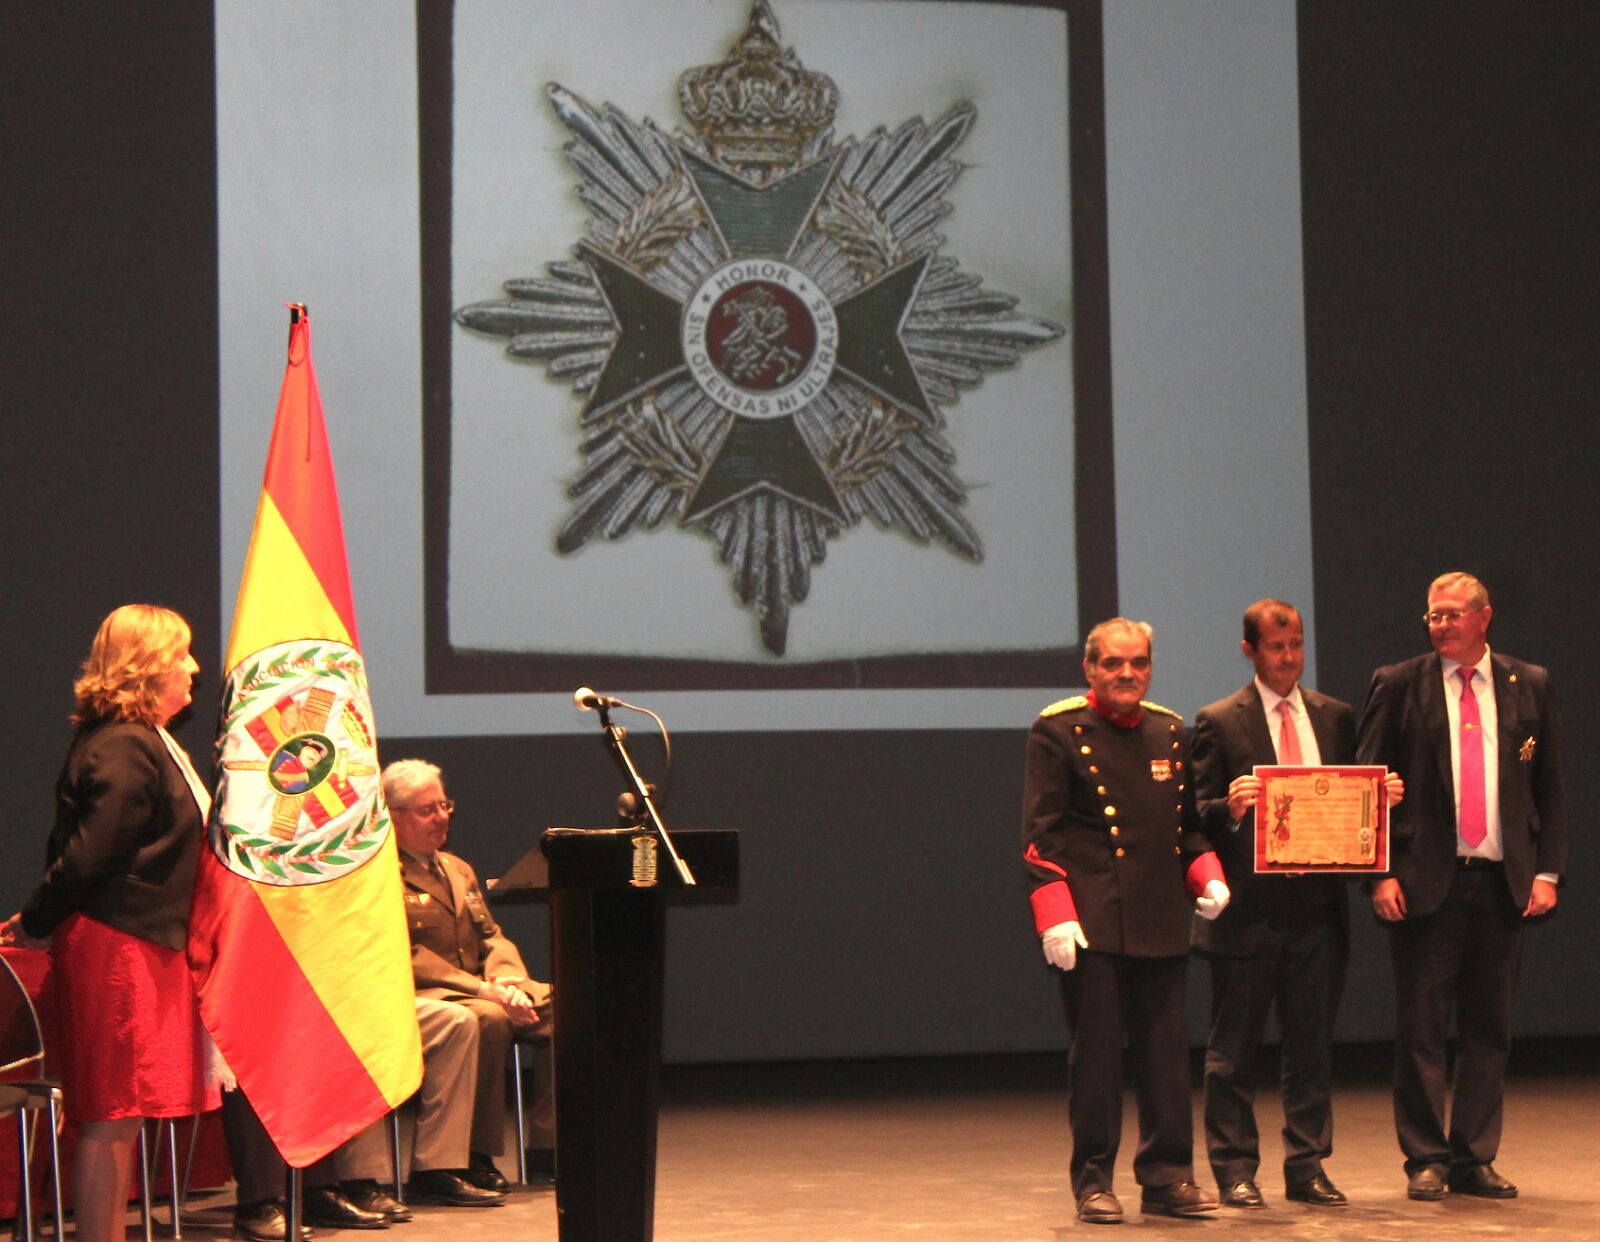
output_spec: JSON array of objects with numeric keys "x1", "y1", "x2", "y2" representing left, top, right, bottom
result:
[{"x1": 678, "y1": 0, "x2": 838, "y2": 181}]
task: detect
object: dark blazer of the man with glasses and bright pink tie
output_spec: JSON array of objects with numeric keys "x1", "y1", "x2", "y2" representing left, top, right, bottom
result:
[{"x1": 1357, "y1": 651, "x2": 1566, "y2": 919}]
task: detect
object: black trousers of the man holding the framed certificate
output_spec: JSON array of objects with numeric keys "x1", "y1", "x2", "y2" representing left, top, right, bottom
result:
[{"x1": 1205, "y1": 887, "x2": 1349, "y2": 1186}]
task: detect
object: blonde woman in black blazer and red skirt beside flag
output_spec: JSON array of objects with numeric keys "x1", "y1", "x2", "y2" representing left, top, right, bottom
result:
[{"x1": 0, "y1": 603, "x2": 219, "y2": 1242}]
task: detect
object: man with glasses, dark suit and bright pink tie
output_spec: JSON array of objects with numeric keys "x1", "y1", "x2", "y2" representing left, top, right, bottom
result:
[{"x1": 1357, "y1": 573, "x2": 1566, "y2": 1199}]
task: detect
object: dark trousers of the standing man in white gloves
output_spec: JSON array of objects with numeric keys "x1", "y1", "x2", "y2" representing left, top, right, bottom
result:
[{"x1": 1058, "y1": 951, "x2": 1194, "y2": 1199}]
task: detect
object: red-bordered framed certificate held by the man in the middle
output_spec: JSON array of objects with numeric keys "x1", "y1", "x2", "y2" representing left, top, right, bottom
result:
[{"x1": 1253, "y1": 765, "x2": 1389, "y2": 874}]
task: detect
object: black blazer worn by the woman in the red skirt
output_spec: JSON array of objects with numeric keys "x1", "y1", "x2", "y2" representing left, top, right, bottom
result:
[{"x1": 22, "y1": 720, "x2": 205, "y2": 949}]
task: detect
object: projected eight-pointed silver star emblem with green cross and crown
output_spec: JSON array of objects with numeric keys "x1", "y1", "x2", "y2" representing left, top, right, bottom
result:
[{"x1": 456, "y1": 0, "x2": 1062, "y2": 655}]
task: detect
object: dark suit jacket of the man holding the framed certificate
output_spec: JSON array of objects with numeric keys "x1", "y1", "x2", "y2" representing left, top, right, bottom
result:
[{"x1": 1192, "y1": 680, "x2": 1355, "y2": 956}]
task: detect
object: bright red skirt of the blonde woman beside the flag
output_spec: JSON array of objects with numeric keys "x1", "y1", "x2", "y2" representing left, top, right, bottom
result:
[{"x1": 50, "y1": 914, "x2": 221, "y2": 1122}]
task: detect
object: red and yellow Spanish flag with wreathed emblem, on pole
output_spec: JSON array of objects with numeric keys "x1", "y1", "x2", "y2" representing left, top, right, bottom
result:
[{"x1": 189, "y1": 306, "x2": 422, "y2": 1168}]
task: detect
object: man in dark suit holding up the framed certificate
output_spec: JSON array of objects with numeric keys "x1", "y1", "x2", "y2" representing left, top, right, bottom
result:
[{"x1": 1194, "y1": 599, "x2": 1402, "y2": 1208}]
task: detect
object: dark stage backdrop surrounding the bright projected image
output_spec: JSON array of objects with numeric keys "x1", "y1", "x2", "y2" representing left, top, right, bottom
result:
[{"x1": 0, "y1": 3, "x2": 1600, "y2": 1060}]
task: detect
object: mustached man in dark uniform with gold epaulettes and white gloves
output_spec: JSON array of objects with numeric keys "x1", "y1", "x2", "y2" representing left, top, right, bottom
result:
[{"x1": 1022, "y1": 616, "x2": 1227, "y2": 1223}]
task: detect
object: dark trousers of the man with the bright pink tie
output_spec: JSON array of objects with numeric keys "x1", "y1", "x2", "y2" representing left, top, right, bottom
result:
[{"x1": 1390, "y1": 863, "x2": 1523, "y2": 1173}]
